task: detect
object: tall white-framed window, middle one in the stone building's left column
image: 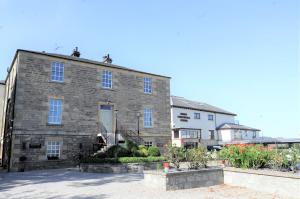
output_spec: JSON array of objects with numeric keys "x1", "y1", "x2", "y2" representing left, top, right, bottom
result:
[{"x1": 48, "y1": 98, "x2": 62, "y2": 124}]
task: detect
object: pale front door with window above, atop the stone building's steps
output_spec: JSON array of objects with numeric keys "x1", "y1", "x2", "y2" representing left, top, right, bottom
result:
[{"x1": 99, "y1": 105, "x2": 115, "y2": 146}]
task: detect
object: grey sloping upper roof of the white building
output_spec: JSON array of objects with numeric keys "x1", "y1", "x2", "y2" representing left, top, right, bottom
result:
[{"x1": 171, "y1": 96, "x2": 236, "y2": 116}]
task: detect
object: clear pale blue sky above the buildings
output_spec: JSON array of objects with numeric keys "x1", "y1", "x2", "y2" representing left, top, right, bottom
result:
[{"x1": 0, "y1": 0, "x2": 300, "y2": 137}]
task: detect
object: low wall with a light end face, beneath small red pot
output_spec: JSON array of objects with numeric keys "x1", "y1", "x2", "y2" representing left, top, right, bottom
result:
[{"x1": 144, "y1": 168, "x2": 224, "y2": 190}]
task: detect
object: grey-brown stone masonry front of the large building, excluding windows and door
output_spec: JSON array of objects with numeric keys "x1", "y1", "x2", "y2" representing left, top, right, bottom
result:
[{"x1": 1, "y1": 50, "x2": 171, "y2": 170}]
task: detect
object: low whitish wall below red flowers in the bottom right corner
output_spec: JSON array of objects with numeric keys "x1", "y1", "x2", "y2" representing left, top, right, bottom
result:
[{"x1": 224, "y1": 168, "x2": 300, "y2": 198}]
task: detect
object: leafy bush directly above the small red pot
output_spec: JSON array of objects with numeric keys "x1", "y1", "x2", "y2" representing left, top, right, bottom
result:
[{"x1": 165, "y1": 144, "x2": 185, "y2": 169}]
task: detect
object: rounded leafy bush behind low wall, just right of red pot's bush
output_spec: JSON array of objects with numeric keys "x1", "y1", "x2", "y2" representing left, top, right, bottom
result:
[{"x1": 186, "y1": 146, "x2": 209, "y2": 169}]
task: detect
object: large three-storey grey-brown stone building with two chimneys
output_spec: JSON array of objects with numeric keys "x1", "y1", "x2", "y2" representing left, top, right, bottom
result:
[{"x1": 0, "y1": 50, "x2": 171, "y2": 170}]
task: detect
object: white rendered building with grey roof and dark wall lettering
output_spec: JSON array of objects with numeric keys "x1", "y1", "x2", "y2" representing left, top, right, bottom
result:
[{"x1": 171, "y1": 96, "x2": 259, "y2": 148}]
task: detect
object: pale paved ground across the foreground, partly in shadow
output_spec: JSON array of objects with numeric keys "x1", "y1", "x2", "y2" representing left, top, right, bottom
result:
[{"x1": 0, "y1": 169, "x2": 286, "y2": 199}]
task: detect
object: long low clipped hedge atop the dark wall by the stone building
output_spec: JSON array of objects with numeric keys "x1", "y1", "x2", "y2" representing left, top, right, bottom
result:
[{"x1": 81, "y1": 156, "x2": 166, "y2": 164}]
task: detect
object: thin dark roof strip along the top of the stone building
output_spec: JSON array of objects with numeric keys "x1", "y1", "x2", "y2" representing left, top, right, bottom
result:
[{"x1": 15, "y1": 49, "x2": 171, "y2": 78}]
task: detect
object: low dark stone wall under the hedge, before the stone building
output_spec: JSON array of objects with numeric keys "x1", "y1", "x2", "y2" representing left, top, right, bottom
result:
[{"x1": 80, "y1": 162, "x2": 162, "y2": 173}]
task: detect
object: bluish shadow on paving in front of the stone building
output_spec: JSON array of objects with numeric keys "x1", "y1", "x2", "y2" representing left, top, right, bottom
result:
[{"x1": 0, "y1": 169, "x2": 144, "y2": 192}]
